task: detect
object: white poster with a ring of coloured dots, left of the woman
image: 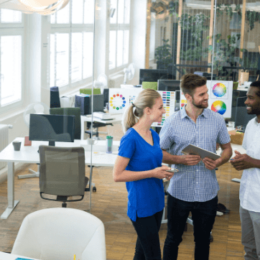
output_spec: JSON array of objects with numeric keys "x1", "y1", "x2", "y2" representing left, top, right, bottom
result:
[{"x1": 109, "y1": 88, "x2": 143, "y2": 114}]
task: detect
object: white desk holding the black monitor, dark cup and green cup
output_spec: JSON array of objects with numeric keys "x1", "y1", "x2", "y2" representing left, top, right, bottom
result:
[{"x1": 0, "y1": 138, "x2": 119, "y2": 219}]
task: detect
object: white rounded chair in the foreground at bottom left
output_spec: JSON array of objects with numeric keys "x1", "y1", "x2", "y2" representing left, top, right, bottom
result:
[{"x1": 12, "y1": 208, "x2": 106, "y2": 260}]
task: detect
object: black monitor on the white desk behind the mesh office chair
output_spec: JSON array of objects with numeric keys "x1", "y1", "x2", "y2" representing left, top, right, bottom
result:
[{"x1": 29, "y1": 114, "x2": 75, "y2": 146}]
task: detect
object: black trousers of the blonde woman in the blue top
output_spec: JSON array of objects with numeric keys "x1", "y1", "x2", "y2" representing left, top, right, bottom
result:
[{"x1": 132, "y1": 211, "x2": 163, "y2": 260}]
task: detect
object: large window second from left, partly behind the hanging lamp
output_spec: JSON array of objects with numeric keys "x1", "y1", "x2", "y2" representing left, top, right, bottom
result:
[{"x1": 50, "y1": 0, "x2": 94, "y2": 87}]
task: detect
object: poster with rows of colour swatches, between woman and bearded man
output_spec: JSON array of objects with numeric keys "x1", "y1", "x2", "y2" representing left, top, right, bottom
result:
[{"x1": 152, "y1": 91, "x2": 176, "y2": 127}]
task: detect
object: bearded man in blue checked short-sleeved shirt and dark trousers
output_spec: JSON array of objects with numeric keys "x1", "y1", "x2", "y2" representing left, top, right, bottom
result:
[{"x1": 160, "y1": 74, "x2": 232, "y2": 260}]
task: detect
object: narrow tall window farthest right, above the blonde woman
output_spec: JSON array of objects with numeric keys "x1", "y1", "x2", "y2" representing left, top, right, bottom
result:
[{"x1": 109, "y1": 0, "x2": 130, "y2": 70}]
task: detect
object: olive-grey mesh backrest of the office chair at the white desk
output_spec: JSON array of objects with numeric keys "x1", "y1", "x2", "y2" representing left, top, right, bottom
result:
[{"x1": 39, "y1": 145, "x2": 86, "y2": 196}]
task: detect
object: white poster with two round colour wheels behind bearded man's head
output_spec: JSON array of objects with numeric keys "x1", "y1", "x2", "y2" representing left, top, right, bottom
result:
[{"x1": 180, "y1": 80, "x2": 233, "y2": 118}]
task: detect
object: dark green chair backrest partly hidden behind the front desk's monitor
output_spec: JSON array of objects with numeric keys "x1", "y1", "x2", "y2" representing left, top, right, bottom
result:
[{"x1": 50, "y1": 107, "x2": 81, "y2": 139}]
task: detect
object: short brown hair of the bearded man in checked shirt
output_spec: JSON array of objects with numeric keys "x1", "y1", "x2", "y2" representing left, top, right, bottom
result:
[{"x1": 181, "y1": 73, "x2": 207, "y2": 96}]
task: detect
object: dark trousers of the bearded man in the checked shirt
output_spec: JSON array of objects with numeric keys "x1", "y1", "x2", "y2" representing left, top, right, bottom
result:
[{"x1": 163, "y1": 195, "x2": 218, "y2": 260}]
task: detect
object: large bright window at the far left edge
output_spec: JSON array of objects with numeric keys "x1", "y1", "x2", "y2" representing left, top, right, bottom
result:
[{"x1": 0, "y1": 9, "x2": 23, "y2": 107}]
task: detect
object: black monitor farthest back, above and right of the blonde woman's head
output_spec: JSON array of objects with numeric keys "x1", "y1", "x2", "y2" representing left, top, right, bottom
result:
[{"x1": 139, "y1": 69, "x2": 175, "y2": 85}]
